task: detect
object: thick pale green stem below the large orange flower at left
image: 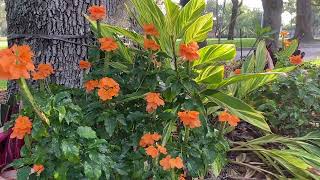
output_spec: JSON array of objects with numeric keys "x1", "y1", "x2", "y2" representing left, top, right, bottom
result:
[{"x1": 18, "y1": 78, "x2": 50, "y2": 125}]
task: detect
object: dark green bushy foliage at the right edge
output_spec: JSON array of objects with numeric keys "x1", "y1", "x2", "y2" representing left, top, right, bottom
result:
[{"x1": 249, "y1": 63, "x2": 320, "y2": 135}]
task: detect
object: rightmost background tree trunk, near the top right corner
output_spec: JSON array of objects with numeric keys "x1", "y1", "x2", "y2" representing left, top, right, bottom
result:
[{"x1": 294, "y1": 0, "x2": 314, "y2": 41}]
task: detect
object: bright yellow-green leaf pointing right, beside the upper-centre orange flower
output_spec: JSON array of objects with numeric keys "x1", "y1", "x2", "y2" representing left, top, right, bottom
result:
[{"x1": 193, "y1": 44, "x2": 236, "y2": 67}]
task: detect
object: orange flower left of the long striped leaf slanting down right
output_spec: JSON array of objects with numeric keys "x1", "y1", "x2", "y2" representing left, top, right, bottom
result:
[{"x1": 178, "y1": 111, "x2": 201, "y2": 128}]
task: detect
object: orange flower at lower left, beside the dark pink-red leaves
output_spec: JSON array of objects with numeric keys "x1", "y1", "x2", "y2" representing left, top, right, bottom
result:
[{"x1": 10, "y1": 116, "x2": 32, "y2": 139}]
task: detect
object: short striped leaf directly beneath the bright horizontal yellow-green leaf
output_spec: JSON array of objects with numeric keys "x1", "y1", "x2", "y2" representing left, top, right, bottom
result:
[{"x1": 195, "y1": 66, "x2": 224, "y2": 84}]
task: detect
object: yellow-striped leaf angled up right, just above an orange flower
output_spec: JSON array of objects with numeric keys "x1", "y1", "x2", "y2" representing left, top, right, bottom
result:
[{"x1": 184, "y1": 13, "x2": 213, "y2": 43}]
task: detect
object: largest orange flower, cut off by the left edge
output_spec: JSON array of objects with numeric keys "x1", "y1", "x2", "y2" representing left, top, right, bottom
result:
[{"x1": 0, "y1": 45, "x2": 35, "y2": 80}]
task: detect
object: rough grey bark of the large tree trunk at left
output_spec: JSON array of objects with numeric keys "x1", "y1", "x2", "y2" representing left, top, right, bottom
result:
[{"x1": 5, "y1": 0, "x2": 129, "y2": 91}]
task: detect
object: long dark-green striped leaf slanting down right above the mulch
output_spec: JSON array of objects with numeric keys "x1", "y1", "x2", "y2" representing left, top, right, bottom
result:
[{"x1": 202, "y1": 90, "x2": 271, "y2": 132}]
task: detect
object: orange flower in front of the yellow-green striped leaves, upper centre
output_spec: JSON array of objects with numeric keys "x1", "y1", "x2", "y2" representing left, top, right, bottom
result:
[{"x1": 179, "y1": 42, "x2": 200, "y2": 62}]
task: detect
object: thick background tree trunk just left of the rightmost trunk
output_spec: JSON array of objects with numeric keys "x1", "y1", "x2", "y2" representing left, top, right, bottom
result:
[{"x1": 262, "y1": 0, "x2": 283, "y2": 51}]
